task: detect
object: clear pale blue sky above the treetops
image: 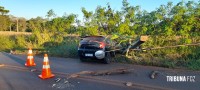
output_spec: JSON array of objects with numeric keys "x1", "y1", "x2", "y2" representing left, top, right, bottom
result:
[{"x1": 0, "y1": 0, "x2": 198, "y2": 19}]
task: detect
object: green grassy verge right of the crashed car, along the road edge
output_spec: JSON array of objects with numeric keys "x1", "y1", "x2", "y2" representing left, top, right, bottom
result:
[{"x1": 115, "y1": 46, "x2": 200, "y2": 70}]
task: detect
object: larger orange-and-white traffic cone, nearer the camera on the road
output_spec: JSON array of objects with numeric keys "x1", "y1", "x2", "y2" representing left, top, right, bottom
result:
[{"x1": 38, "y1": 54, "x2": 55, "y2": 79}]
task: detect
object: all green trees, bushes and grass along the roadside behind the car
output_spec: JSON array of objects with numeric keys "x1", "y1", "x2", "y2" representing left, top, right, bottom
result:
[{"x1": 0, "y1": 0, "x2": 200, "y2": 70}]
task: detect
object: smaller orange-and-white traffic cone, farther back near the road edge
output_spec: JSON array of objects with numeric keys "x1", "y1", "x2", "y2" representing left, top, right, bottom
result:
[{"x1": 25, "y1": 48, "x2": 36, "y2": 67}]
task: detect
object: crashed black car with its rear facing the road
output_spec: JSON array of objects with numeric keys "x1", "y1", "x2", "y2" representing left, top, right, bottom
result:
[{"x1": 78, "y1": 36, "x2": 119, "y2": 63}]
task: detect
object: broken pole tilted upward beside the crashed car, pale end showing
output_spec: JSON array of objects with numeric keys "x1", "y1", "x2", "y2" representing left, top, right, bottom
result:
[{"x1": 123, "y1": 36, "x2": 148, "y2": 56}]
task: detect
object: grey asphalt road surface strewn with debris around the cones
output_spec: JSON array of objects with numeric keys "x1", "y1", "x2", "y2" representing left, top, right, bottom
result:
[{"x1": 0, "y1": 53, "x2": 200, "y2": 90}]
